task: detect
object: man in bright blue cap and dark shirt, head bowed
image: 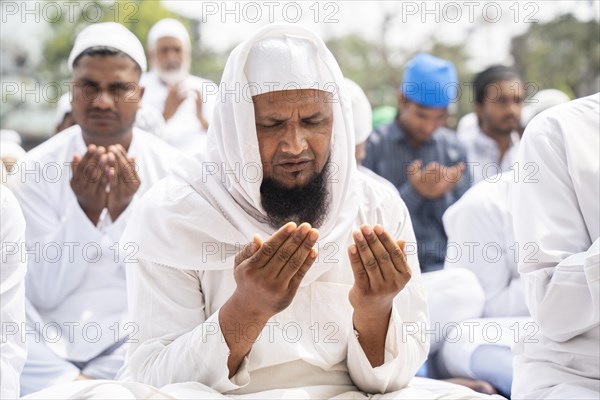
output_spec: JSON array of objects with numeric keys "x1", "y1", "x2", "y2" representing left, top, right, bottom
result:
[{"x1": 363, "y1": 53, "x2": 470, "y2": 272}]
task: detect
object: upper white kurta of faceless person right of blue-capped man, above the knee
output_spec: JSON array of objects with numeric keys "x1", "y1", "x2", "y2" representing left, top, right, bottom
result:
[{"x1": 443, "y1": 172, "x2": 535, "y2": 317}]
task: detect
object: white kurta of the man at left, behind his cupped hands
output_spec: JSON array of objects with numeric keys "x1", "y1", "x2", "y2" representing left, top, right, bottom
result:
[{"x1": 13, "y1": 125, "x2": 178, "y2": 361}]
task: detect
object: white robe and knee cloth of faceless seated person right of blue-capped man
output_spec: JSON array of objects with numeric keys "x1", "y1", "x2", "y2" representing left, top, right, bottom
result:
[{"x1": 438, "y1": 171, "x2": 533, "y2": 378}]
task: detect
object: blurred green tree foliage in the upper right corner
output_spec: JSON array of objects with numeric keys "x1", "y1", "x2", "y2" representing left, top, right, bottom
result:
[{"x1": 511, "y1": 14, "x2": 600, "y2": 98}]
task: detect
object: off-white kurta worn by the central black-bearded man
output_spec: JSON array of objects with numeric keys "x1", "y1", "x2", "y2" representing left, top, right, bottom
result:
[{"x1": 123, "y1": 174, "x2": 428, "y2": 397}]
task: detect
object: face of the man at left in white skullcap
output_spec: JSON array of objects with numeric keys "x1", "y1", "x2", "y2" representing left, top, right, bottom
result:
[{"x1": 71, "y1": 56, "x2": 144, "y2": 138}]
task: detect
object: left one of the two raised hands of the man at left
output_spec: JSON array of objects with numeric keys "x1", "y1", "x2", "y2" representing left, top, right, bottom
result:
[{"x1": 71, "y1": 144, "x2": 108, "y2": 225}]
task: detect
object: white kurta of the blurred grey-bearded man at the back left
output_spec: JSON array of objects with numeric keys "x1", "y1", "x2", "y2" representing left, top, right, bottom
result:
[{"x1": 140, "y1": 71, "x2": 217, "y2": 154}]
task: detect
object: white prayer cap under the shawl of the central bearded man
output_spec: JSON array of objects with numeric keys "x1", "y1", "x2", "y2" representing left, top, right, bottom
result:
[{"x1": 244, "y1": 35, "x2": 336, "y2": 97}]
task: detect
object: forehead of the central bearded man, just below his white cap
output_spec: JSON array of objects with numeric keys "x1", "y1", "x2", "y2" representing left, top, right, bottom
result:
[{"x1": 252, "y1": 89, "x2": 333, "y2": 117}]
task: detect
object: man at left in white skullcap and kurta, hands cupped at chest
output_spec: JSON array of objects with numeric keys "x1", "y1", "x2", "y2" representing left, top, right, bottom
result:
[{"x1": 13, "y1": 23, "x2": 177, "y2": 394}]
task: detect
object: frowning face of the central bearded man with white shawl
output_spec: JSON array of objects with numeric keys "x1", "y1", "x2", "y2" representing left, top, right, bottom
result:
[{"x1": 252, "y1": 89, "x2": 333, "y2": 188}]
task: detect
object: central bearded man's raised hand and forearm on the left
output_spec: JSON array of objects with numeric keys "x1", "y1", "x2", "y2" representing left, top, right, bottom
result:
[{"x1": 219, "y1": 222, "x2": 319, "y2": 378}]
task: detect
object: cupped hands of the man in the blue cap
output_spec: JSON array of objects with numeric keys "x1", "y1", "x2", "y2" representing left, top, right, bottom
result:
[{"x1": 407, "y1": 160, "x2": 465, "y2": 200}]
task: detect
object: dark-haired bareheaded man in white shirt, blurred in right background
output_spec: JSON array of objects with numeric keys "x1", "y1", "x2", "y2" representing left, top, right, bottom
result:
[{"x1": 459, "y1": 65, "x2": 525, "y2": 183}]
